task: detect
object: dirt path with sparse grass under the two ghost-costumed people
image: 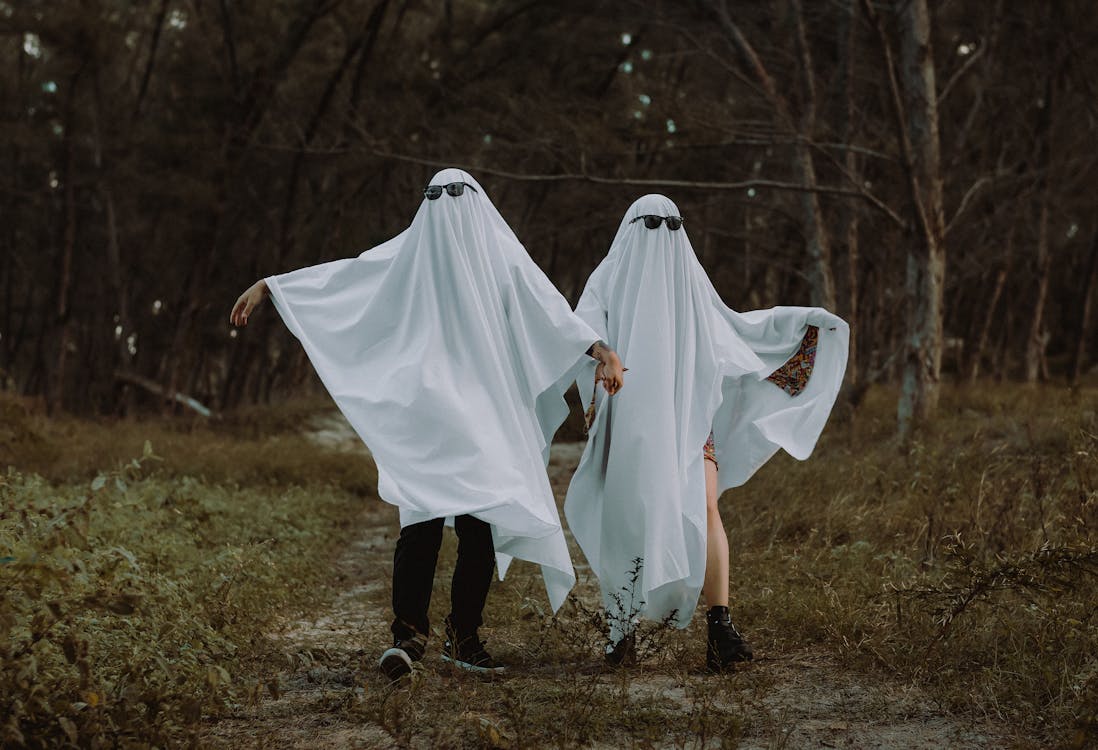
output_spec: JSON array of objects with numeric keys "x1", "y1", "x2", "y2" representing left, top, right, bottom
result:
[{"x1": 203, "y1": 414, "x2": 1017, "y2": 750}]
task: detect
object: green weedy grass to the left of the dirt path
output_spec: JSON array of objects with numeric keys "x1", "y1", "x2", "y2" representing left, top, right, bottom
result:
[{"x1": 0, "y1": 404, "x2": 376, "y2": 748}]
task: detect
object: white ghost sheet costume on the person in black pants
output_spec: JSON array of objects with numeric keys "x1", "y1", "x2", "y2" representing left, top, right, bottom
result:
[{"x1": 266, "y1": 169, "x2": 598, "y2": 611}]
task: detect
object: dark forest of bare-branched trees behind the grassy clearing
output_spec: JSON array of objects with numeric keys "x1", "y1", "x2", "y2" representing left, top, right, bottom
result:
[{"x1": 0, "y1": 0, "x2": 1098, "y2": 432}]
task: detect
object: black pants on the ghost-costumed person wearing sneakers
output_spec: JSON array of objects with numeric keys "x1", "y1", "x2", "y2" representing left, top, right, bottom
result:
[{"x1": 392, "y1": 516, "x2": 495, "y2": 639}]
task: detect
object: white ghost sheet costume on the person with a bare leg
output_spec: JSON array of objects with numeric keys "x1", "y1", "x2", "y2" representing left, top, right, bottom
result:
[{"x1": 564, "y1": 194, "x2": 849, "y2": 641}]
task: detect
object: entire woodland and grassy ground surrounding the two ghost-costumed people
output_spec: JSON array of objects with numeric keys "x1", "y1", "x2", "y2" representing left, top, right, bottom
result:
[{"x1": 0, "y1": 0, "x2": 1098, "y2": 750}]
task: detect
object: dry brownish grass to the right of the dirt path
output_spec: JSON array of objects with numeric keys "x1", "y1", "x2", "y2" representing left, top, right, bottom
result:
[{"x1": 724, "y1": 385, "x2": 1098, "y2": 747}]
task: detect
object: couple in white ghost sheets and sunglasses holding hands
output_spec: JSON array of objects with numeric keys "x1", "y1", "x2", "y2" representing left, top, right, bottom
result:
[{"x1": 232, "y1": 169, "x2": 849, "y2": 680}]
